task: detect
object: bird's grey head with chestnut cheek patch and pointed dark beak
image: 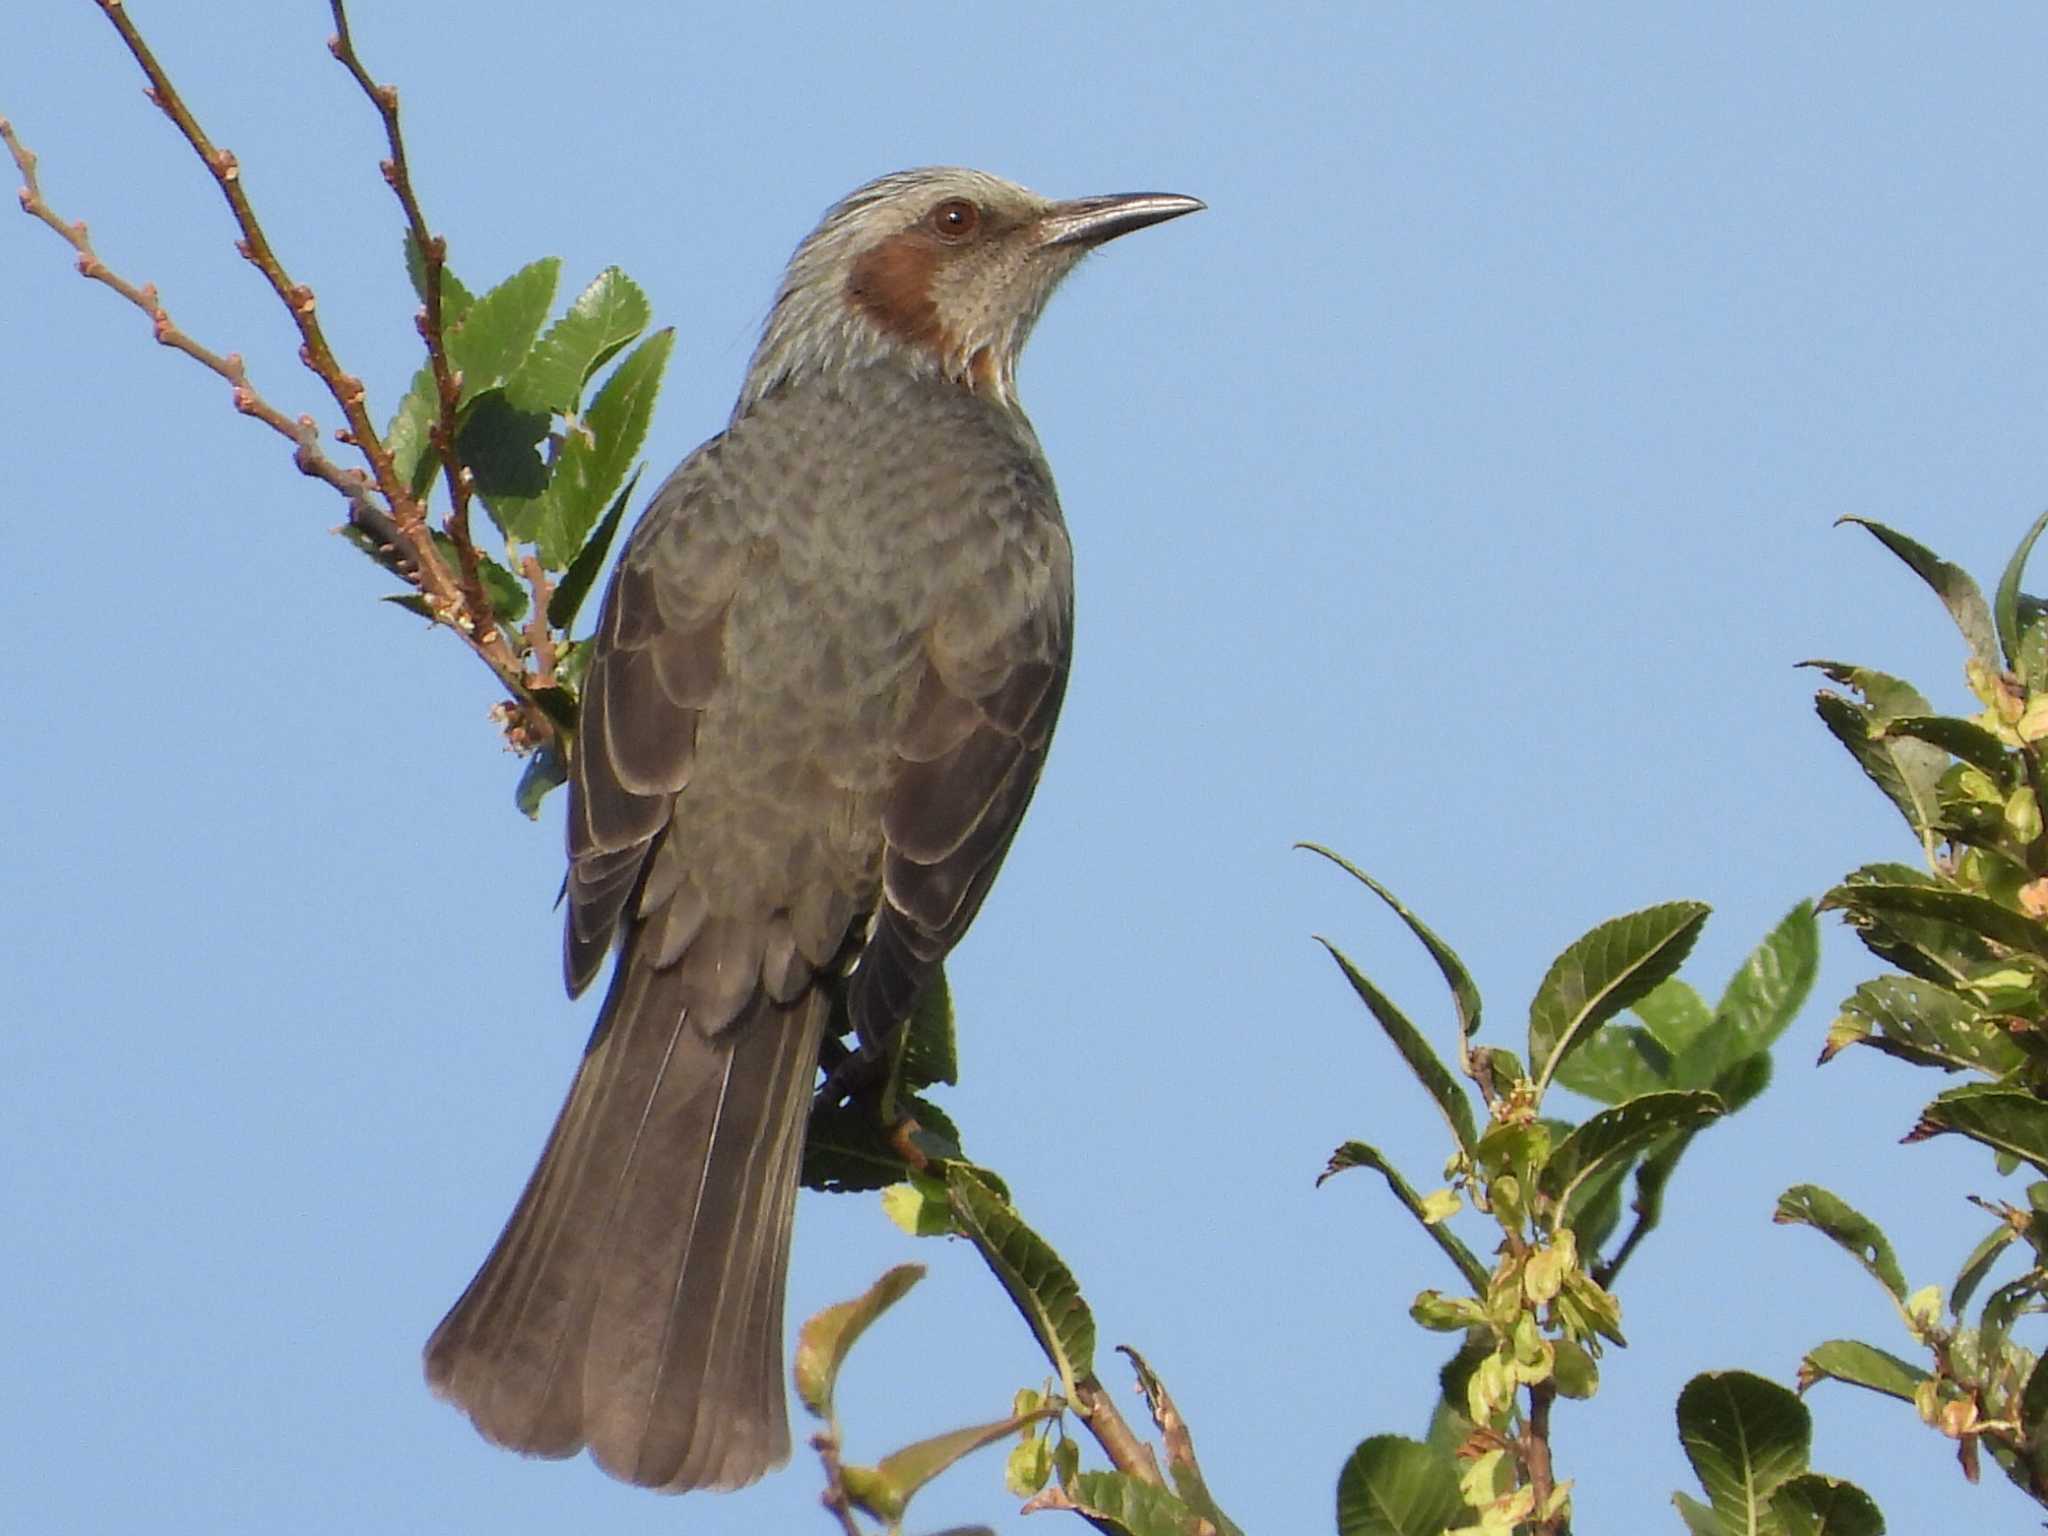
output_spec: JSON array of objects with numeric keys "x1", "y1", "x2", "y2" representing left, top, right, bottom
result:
[{"x1": 735, "y1": 168, "x2": 1202, "y2": 416}]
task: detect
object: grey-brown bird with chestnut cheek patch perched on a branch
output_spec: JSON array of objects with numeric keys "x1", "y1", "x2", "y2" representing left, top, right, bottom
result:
[{"x1": 424, "y1": 168, "x2": 1204, "y2": 1493}]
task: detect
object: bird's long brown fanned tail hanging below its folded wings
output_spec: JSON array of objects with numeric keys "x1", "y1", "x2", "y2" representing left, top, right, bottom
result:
[{"x1": 426, "y1": 952, "x2": 829, "y2": 1493}]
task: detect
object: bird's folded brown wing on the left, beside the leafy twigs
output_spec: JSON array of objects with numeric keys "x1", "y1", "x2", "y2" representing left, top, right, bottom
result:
[{"x1": 563, "y1": 449, "x2": 745, "y2": 995}]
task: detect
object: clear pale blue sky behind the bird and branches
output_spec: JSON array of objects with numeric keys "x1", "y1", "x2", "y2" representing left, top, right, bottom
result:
[{"x1": 0, "y1": 0, "x2": 2048, "y2": 1532}]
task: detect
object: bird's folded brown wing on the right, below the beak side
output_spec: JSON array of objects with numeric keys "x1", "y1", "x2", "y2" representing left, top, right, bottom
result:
[{"x1": 850, "y1": 520, "x2": 1073, "y2": 1040}]
